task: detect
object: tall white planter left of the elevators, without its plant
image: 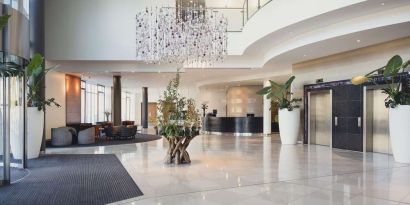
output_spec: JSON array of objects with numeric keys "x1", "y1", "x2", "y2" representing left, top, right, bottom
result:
[{"x1": 279, "y1": 108, "x2": 300, "y2": 145}]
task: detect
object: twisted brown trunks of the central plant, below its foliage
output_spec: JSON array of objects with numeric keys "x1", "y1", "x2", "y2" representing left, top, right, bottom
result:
[{"x1": 164, "y1": 137, "x2": 193, "y2": 164}]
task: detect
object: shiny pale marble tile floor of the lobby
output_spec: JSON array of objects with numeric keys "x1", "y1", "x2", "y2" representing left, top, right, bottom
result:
[{"x1": 47, "y1": 135, "x2": 410, "y2": 205}]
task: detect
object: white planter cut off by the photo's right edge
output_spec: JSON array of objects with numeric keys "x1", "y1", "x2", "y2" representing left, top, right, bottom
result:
[{"x1": 389, "y1": 105, "x2": 410, "y2": 163}]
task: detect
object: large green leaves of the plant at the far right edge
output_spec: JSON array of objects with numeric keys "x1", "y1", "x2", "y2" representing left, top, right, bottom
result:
[{"x1": 352, "y1": 55, "x2": 410, "y2": 108}]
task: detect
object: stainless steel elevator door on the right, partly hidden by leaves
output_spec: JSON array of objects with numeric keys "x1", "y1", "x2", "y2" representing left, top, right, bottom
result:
[{"x1": 366, "y1": 89, "x2": 391, "y2": 154}]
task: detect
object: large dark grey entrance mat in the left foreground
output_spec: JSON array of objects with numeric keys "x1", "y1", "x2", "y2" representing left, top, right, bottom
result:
[{"x1": 0, "y1": 154, "x2": 143, "y2": 205}]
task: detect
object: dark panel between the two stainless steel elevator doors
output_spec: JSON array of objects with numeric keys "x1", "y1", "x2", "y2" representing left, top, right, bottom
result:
[{"x1": 332, "y1": 85, "x2": 363, "y2": 151}]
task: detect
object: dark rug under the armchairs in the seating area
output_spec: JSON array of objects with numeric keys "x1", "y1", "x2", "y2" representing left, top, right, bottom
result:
[{"x1": 47, "y1": 133, "x2": 161, "y2": 148}]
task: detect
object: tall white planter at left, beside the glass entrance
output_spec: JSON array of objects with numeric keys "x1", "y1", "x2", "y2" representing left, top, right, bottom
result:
[{"x1": 10, "y1": 107, "x2": 44, "y2": 159}]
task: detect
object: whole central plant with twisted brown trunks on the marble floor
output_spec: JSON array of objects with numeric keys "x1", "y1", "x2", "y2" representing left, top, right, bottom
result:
[{"x1": 157, "y1": 73, "x2": 200, "y2": 164}]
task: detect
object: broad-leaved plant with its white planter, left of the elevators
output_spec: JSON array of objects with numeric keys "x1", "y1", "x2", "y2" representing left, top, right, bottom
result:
[{"x1": 257, "y1": 76, "x2": 302, "y2": 145}]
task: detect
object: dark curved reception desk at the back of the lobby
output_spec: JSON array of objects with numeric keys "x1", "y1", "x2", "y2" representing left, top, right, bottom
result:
[{"x1": 203, "y1": 116, "x2": 263, "y2": 134}]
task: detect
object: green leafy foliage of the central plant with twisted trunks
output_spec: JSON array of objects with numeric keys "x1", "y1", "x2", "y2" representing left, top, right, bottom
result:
[{"x1": 157, "y1": 73, "x2": 200, "y2": 138}]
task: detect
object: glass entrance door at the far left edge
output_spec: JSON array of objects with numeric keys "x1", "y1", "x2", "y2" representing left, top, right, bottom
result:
[{"x1": 0, "y1": 52, "x2": 27, "y2": 186}]
